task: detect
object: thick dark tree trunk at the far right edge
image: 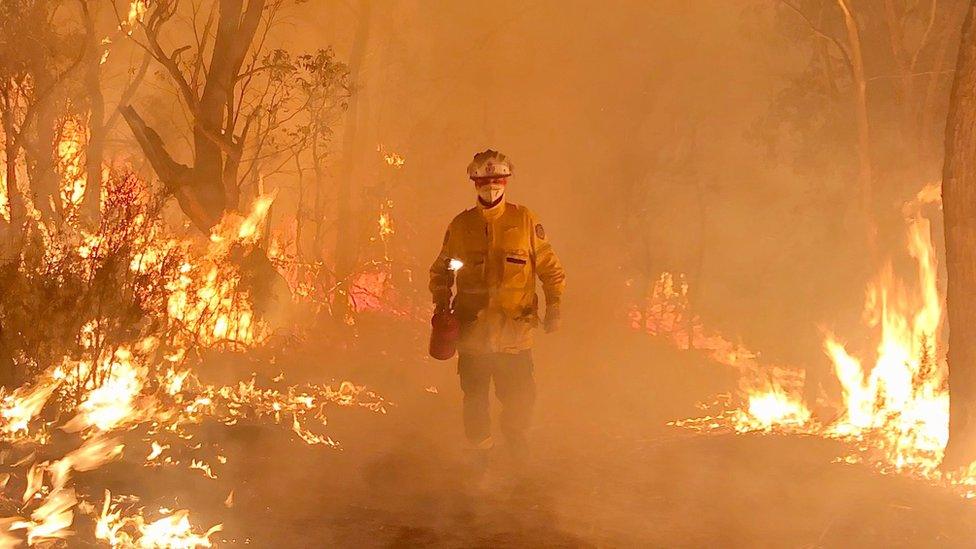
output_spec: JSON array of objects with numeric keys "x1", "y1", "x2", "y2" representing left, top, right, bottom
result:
[{"x1": 942, "y1": 0, "x2": 976, "y2": 469}]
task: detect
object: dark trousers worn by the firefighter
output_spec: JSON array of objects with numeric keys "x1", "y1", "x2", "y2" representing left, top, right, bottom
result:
[{"x1": 458, "y1": 351, "x2": 535, "y2": 444}]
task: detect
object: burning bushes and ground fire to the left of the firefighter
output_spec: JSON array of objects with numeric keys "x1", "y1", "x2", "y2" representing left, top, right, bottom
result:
[{"x1": 0, "y1": 163, "x2": 385, "y2": 548}]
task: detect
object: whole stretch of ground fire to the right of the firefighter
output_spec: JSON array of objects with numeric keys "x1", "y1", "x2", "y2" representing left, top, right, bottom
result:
[{"x1": 656, "y1": 185, "x2": 976, "y2": 498}]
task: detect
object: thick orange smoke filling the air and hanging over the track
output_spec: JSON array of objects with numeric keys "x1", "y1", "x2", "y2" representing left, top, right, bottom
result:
[{"x1": 7, "y1": 0, "x2": 976, "y2": 547}]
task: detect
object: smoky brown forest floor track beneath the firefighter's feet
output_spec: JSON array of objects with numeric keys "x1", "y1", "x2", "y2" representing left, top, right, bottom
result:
[{"x1": 74, "y1": 314, "x2": 976, "y2": 548}]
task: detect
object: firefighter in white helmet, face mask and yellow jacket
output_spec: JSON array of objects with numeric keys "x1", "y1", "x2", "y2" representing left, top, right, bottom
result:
[{"x1": 430, "y1": 150, "x2": 565, "y2": 459}]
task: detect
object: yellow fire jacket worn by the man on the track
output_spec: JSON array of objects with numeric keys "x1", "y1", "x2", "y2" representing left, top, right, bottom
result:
[{"x1": 430, "y1": 201, "x2": 566, "y2": 353}]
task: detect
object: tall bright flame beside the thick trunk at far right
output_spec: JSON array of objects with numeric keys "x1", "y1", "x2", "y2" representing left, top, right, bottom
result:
[{"x1": 824, "y1": 194, "x2": 949, "y2": 474}]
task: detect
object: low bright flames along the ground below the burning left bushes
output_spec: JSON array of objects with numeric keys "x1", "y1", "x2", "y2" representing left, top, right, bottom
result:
[{"x1": 0, "y1": 332, "x2": 385, "y2": 547}]
